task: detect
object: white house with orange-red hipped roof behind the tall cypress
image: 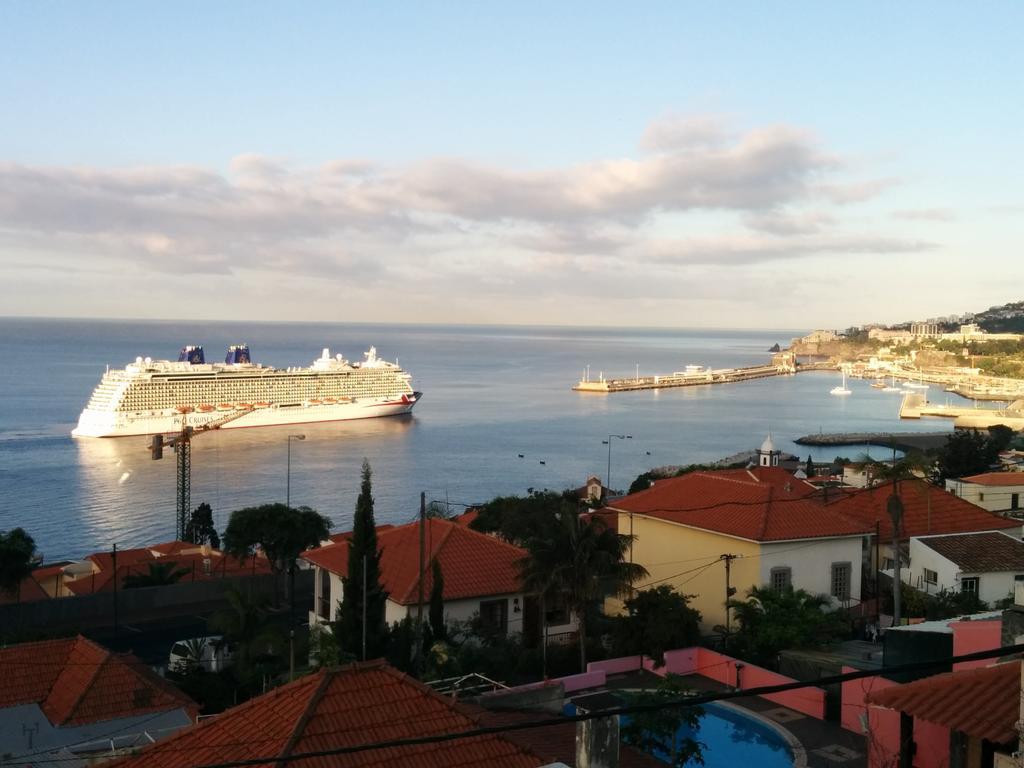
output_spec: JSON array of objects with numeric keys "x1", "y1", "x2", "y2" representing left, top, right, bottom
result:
[{"x1": 302, "y1": 518, "x2": 572, "y2": 635}]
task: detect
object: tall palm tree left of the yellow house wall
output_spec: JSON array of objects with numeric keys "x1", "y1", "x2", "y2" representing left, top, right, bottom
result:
[{"x1": 519, "y1": 510, "x2": 647, "y2": 671}]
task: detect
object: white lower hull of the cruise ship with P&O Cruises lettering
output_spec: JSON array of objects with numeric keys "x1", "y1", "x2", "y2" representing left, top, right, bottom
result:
[{"x1": 72, "y1": 392, "x2": 422, "y2": 437}]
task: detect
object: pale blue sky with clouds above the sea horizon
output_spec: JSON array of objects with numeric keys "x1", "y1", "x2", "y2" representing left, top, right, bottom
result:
[{"x1": 0, "y1": 0, "x2": 1024, "y2": 329}]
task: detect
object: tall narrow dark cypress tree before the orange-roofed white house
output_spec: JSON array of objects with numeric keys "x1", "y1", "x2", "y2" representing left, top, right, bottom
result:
[{"x1": 335, "y1": 459, "x2": 387, "y2": 658}]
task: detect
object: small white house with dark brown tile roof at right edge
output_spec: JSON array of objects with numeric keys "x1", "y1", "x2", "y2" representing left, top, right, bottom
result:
[{"x1": 906, "y1": 530, "x2": 1024, "y2": 604}]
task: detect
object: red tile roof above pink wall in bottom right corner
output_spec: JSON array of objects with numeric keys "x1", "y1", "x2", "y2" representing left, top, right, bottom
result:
[{"x1": 867, "y1": 662, "x2": 1021, "y2": 744}]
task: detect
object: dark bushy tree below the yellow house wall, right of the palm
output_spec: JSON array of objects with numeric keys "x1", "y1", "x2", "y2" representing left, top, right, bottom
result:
[{"x1": 611, "y1": 585, "x2": 701, "y2": 665}]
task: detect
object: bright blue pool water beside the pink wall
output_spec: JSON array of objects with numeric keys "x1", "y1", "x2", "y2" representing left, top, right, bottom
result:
[{"x1": 565, "y1": 703, "x2": 794, "y2": 768}]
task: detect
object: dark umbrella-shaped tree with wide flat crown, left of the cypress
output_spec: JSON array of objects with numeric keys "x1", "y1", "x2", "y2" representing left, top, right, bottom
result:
[{"x1": 224, "y1": 503, "x2": 331, "y2": 618}]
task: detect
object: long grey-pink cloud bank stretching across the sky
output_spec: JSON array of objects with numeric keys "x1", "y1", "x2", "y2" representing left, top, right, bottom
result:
[{"x1": 0, "y1": 115, "x2": 934, "y2": 317}]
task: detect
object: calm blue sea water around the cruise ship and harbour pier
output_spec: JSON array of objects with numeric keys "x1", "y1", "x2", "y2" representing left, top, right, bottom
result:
[{"x1": 0, "y1": 318, "x2": 950, "y2": 560}]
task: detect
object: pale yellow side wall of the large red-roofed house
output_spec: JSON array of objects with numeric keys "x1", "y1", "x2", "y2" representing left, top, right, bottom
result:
[{"x1": 606, "y1": 512, "x2": 761, "y2": 631}]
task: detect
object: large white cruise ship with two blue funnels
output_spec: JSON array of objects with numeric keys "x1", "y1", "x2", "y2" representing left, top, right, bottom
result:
[{"x1": 72, "y1": 344, "x2": 421, "y2": 437}]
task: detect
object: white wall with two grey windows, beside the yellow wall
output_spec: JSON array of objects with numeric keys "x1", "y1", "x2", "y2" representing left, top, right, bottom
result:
[{"x1": 761, "y1": 537, "x2": 862, "y2": 604}]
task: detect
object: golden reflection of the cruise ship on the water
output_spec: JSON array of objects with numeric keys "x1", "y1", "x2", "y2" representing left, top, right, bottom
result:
[{"x1": 73, "y1": 415, "x2": 415, "y2": 557}]
